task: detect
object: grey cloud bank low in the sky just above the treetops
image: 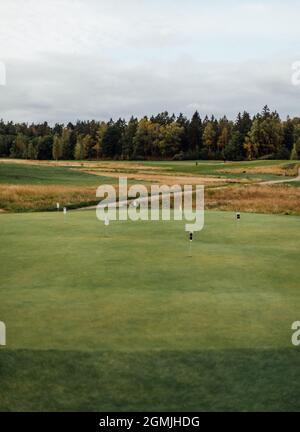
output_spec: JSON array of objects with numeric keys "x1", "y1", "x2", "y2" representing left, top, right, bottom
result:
[{"x1": 0, "y1": 55, "x2": 300, "y2": 123}]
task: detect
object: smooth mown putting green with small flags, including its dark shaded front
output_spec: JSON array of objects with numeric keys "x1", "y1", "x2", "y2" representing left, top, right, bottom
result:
[{"x1": 0, "y1": 211, "x2": 300, "y2": 411}]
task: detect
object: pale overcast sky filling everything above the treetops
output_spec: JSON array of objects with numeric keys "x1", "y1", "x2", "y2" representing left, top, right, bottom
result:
[{"x1": 0, "y1": 0, "x2": 300, "y2": 123}]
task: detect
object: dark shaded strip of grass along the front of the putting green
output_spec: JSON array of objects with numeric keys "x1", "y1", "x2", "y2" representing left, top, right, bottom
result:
[{"x1": 0, "y1": 348, "x2": 300, "y2": 411}]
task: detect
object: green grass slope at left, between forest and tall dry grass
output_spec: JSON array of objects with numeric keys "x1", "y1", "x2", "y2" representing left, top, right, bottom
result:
[{"x1": 0, "y1": 162, "x2": 115, "y2": 186}]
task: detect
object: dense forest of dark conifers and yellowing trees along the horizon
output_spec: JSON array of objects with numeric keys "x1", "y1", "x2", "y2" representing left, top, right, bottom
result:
[{"x1": 0, "y1": 106, "x2": 300, "y2": 160}]
